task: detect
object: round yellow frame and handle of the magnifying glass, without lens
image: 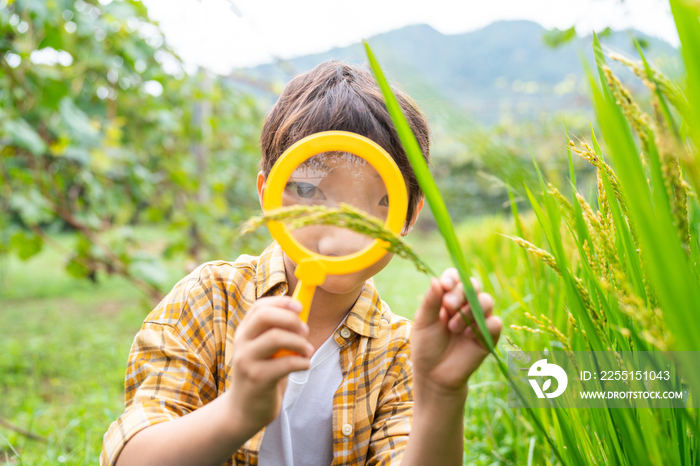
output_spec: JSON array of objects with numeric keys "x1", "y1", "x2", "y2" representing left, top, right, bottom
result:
[{"x1": 263, "y1": 131, "x2": 408, "y2": 328}]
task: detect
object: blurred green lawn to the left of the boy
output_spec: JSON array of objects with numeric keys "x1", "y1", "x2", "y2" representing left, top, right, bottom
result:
[{"x1": 0, "y1": 246, "x2": 143, "y2": 465}]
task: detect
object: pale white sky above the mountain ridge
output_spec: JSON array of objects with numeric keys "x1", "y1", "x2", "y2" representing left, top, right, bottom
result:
[{"x1": 143, "y1": 0, "x2": 678, "y2": 74}]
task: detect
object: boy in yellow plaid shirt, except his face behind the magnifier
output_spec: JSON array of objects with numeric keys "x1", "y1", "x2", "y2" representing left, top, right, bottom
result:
[{"x1": 101, "y1": 61, "x2": 502, "y2": 466}]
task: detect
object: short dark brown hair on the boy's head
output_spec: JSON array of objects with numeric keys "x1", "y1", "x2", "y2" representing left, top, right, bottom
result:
[{"x1": 260, "y1": 60, "x2": 430, "y2": 230}]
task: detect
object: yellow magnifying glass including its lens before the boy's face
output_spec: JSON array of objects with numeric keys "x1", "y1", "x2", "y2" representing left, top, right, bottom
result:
[{"x1": 263, "y1": 131, "x2": 408, "y2": 357}]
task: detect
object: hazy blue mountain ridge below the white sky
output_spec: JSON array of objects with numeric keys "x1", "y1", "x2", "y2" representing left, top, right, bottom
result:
[{"x1": 230, "y1": 21, "x2": 680, "y2": 125}]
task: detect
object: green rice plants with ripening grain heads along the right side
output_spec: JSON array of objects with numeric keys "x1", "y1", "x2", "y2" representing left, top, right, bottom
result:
[{"x1": 370, "y1": 0, "x2": 700, "y2": 466}]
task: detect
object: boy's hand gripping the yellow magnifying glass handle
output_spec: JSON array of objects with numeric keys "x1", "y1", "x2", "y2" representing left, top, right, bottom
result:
[{"x1": 225, "y1": 296, "x2": 314, "y2": 437}]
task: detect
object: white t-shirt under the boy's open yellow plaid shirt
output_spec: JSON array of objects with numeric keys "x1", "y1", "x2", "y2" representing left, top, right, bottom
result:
[{"x1": 258, "y1": 323, "x2": 344, "y2": 466}]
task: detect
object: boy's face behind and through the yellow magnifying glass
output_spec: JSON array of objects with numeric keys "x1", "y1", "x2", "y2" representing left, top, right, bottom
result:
[{"x1": 259, "y1": 152, "x2": 418, "y2": 294}]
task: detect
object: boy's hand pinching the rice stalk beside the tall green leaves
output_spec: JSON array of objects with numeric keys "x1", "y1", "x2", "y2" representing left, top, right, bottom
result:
[{"x1": 411, "y1": 268, "x2": 503, "y2": 397}]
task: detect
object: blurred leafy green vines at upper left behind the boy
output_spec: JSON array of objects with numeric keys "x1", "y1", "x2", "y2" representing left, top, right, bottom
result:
[{"x1": 0, "y1": 0, "x2": 262, "y2": 299}]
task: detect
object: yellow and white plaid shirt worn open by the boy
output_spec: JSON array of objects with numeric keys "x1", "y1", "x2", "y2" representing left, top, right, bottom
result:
[{"x1": 100, "y1": 242, "x2": 413, "y2": 465}]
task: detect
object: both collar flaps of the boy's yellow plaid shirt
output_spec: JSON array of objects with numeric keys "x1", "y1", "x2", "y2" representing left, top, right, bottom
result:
[{"x1": 255, "y1": 241, "x2": 382, "y2": 338}]
